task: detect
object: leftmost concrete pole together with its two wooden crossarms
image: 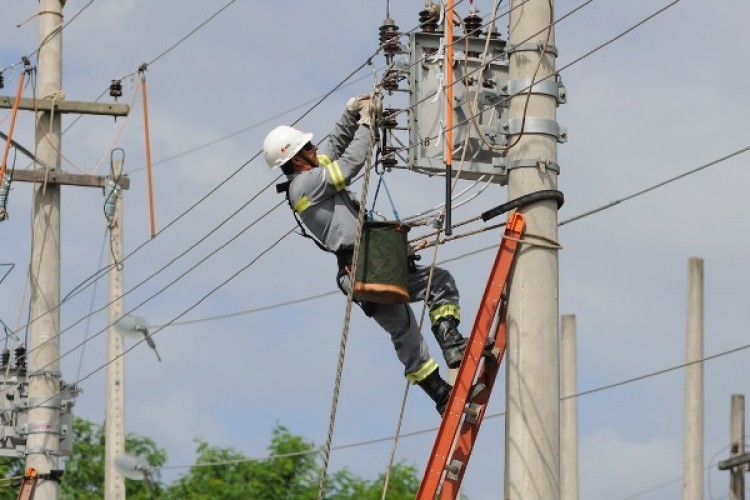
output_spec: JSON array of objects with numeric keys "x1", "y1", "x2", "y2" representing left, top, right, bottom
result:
[{"x1": 0, "y1": 0, "x2": 130, "y2": 500}]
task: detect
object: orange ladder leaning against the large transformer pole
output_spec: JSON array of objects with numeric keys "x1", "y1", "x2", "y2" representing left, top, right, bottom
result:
[{"x1": 417, "y1": 212, "x2": 526, "y2": 500}]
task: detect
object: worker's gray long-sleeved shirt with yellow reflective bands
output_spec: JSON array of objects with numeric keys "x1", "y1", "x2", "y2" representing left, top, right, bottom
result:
[{"x1": 289, "y1": 112, "x2": 370, "y2": 252}]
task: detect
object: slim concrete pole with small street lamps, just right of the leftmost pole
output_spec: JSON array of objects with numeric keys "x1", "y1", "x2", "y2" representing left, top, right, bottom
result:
[{"x1": 104, "y1": 161, "x2": 125, "y2": 500}]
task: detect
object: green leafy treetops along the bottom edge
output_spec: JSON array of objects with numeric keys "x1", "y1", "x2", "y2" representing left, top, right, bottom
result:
[{"x1": 0, "y1": 418, "x2": 419, "y2": 500}]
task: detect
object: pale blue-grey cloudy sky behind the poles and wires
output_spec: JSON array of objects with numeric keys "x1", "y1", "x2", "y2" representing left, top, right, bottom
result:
[{"x1": 0, "y1": 0, "x2": 750, "y2": 499}]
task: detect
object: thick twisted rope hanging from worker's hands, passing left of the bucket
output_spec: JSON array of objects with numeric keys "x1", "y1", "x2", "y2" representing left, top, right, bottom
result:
[{"x1": 318, "y1": 92, "x2": 380, "y2": 500}]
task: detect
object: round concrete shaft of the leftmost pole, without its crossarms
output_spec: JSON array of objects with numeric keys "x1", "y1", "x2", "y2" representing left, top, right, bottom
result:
[{"x1": 26, "y1": 0, "x2": 63, "y2": 500}]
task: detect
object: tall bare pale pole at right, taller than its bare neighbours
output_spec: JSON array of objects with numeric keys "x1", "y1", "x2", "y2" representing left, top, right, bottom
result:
[{"x1": 682, "y1": 257, "x2": 703, "y2": 500}]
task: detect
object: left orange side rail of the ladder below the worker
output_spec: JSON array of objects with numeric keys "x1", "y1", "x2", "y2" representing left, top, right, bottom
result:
[{"x1": 417, "y1": 212, "x2": 525, "y2": 500}]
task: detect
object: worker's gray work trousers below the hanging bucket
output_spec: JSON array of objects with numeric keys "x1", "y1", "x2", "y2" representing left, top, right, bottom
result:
[{"x1": 338, "y1": 266, "x2": 459, "y2": 382}]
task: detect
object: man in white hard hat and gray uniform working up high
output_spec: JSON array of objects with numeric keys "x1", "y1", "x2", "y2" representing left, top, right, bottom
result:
[{"x1": 263, "y1": 94, "x2": 466, "y2": 415}]
